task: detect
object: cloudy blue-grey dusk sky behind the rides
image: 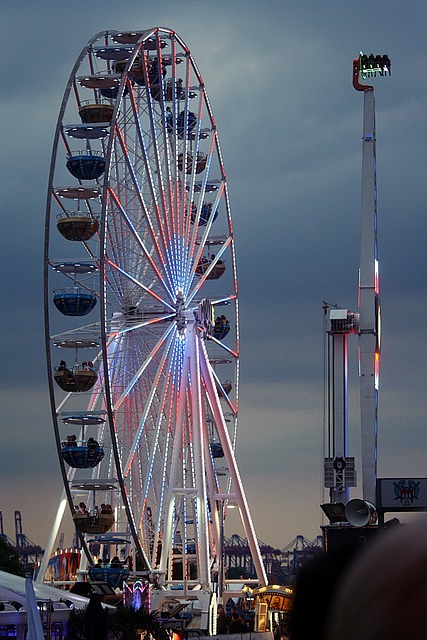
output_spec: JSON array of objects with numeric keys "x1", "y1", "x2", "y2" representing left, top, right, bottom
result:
[{"x1": 0, "y1": 0, "x2": 427, "y2": 548}]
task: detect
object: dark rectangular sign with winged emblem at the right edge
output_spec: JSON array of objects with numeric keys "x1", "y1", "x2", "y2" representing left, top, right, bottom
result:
[{"x1": 377, "y1": 476, "x2": 427, "y2": 512}]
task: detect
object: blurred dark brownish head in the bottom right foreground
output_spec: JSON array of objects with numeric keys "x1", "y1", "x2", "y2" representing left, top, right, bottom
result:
[{"x1": 327, "y1": 520, "x2": 427, "y2": 640}]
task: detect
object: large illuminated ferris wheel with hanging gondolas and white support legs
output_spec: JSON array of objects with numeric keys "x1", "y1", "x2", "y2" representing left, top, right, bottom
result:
[{"x1": 40, "y1": 28, "x2": 266, "y2": 600}]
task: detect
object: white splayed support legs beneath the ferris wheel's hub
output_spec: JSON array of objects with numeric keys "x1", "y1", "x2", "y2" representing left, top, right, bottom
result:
[{"x1": 151, "y1": 313, "x2": 268, "y2": 616}]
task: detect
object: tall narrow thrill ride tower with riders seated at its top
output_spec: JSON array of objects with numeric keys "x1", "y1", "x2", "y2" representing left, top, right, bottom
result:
[{"x1": 322, "y1": 53, "x2": 391, "y2": 526}]
